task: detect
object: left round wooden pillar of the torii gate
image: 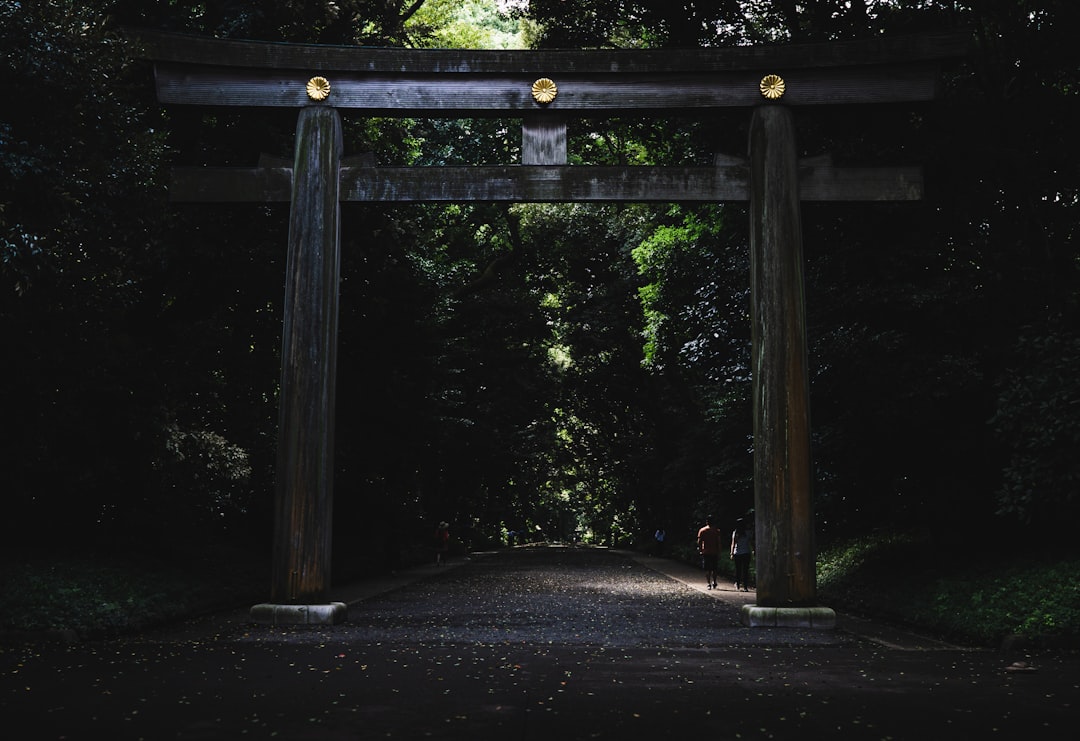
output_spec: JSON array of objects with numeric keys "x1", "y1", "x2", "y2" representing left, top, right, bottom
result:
[{"x1": 271, "y1": 107, "x2": 342, "y2": 604}]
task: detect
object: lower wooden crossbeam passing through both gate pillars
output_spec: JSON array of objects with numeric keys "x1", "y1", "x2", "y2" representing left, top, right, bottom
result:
[{"x1": 168, "y1": 165, "x2": 922, "y2": 203}]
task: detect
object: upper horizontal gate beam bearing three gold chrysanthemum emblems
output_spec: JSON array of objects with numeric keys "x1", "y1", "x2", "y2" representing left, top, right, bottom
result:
[{"x1": 157, "y1": 64, "x2": 940, "y2": 111}]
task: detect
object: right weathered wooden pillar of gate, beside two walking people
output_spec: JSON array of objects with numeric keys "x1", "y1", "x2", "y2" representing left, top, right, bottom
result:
[{"x1": 750, "y1": 105, "x2": 816, "y2": 607}]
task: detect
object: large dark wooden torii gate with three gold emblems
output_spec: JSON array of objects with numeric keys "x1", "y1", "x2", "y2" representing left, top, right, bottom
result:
[{"x1": 133, "y1": 30, "x2": 968, "y2": 628}]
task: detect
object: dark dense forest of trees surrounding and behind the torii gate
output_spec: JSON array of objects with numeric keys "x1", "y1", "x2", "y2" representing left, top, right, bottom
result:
[{"x1": 0, "y1": 0, "x2": 1080, "y2": 587}]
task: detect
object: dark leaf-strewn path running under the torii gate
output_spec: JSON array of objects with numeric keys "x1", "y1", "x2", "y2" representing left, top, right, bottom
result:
[{"x1": 0, "y1": 548, "x2": 1080, "y2": 741}]
